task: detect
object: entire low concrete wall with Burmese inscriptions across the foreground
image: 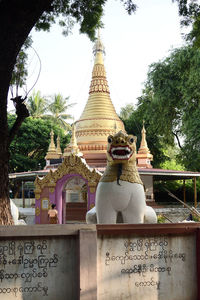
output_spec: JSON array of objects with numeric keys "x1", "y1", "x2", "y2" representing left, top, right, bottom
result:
[{"x1": 0, "y1": 224, "x2": 200, "y2": 300}]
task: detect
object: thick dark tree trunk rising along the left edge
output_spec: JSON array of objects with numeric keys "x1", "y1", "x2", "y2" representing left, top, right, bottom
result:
[{"x1": 0, "y1": 0, "x2": 53, "y2": 225}]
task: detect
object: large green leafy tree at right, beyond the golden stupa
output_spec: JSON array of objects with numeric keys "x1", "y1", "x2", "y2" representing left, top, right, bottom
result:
[{"x1": 137, "y1": 46, "x2": 200, "y2": 171}]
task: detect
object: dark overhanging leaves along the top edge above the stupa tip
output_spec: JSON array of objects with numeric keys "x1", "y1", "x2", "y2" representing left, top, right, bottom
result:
[{"x1": 35, "y1": 0, "x2": 136, "y2": 39}]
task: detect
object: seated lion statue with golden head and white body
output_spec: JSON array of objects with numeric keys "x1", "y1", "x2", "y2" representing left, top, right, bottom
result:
[{"x1": 86, "y1": 131, "x2": 157, "y2": 224}]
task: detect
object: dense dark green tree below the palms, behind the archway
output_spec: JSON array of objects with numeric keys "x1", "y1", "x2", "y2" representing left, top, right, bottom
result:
[{"x1": 8, "y1": 115, "x2": 69, "y2": 173}]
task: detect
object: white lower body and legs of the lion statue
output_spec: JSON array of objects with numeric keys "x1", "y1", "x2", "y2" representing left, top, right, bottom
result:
[{"x1": 86, "y1": 181, "x2": 157, "y2": 224}]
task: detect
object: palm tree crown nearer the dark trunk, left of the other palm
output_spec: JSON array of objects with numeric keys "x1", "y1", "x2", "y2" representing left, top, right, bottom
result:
[{"x1": 27, "y1": 91, "x2": 47, "y2": 118}]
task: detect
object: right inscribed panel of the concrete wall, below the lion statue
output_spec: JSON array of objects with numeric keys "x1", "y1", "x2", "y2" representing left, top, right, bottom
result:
[{"x1": 97, "y1": 226, "x2": 197, "y2": 300}]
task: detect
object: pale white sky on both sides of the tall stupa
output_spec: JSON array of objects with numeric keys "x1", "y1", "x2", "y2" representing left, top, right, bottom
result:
[{"x1": 9, "y1": 0, "x2": 184, "y2": 120}]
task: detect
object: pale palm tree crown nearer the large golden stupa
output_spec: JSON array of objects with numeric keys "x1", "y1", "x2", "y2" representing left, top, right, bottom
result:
[{"x1": 48, "y1": 94, "x2": 76, "y2": 131}]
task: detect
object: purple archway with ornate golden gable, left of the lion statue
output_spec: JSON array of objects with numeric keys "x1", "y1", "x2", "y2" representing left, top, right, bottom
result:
[{"x1": 35, "y1": 155, "x2": 101, "y2": 224}]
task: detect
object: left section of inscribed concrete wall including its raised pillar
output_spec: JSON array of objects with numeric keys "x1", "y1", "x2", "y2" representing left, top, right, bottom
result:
[{"x1": 0, "y1": 225, "x2": 96, "y2": 300}]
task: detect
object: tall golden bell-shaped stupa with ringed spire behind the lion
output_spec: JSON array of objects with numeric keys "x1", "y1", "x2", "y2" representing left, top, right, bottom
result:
[{"x1": 76, "y1": 30, "x2": 125, "y2": 167}]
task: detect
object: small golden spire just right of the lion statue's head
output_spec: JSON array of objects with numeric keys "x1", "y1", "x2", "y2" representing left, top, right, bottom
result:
[{"x1": 136, "y1": 121, "x2": 153, "y2": 168}]
